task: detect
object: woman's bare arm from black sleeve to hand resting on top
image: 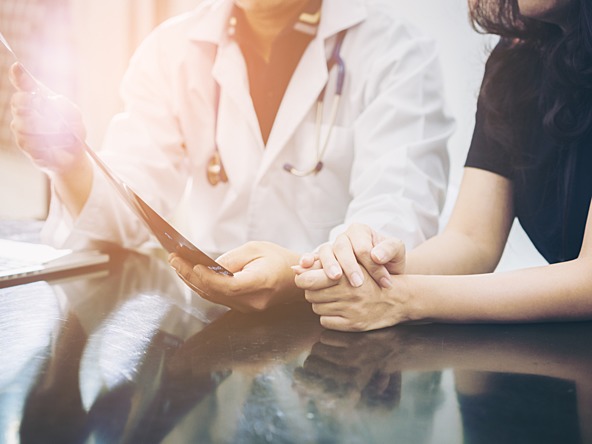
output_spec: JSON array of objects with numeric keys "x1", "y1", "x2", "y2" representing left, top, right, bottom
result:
[{"x1": 306, "y1": 168, "x2": 514, "y2": 288}]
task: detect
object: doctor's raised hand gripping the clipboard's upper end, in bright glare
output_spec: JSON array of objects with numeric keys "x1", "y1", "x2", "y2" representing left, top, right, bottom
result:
[{"x1": 10, "y1": 63, "x2": 88, "y2": 174}]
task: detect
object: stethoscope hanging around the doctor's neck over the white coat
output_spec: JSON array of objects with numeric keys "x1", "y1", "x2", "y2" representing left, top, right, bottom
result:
[{"x1": 206, "y1": 30, "x2": 347, "y2": 186}]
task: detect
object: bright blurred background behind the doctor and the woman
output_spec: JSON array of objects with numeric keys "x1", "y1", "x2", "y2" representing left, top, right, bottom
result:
[{"x1": 0, "y1": 0, "x2": 539, "y2": 263}]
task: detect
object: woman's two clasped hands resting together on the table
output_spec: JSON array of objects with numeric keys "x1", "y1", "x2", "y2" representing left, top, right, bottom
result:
[{"x1": 294, "y1": 224, "x2": 409, "y2": 331}]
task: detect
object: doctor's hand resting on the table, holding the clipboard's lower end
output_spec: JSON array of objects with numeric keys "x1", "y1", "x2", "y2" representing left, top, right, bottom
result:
[{"x1": 169, "y1": 242, "x2": 304, "y2": 312}]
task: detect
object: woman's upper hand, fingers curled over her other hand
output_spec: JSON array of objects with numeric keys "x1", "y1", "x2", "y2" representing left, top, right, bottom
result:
[{"x1": 295, "y1": 224, "x2": 406, "y2": 289}]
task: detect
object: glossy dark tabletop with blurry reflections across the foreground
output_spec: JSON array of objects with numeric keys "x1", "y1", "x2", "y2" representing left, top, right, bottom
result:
[{"x1": 0, "y1": 246, "x2": 592, "y2": 444}]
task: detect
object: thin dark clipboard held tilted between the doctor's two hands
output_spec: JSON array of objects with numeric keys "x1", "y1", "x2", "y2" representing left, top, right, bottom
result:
[{"x1": 0, "y1": 32, "x2": 233, "y2": 276}]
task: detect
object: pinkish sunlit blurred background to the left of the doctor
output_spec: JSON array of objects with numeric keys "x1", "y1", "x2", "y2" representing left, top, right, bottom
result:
[{"x1": 0, "y1": 0, "x2": 199, "y2": 219}]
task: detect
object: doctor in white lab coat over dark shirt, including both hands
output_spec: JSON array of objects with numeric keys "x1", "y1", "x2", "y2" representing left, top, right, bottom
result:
[{"x1": 11, "y1": 0, "x2": 453, "y2": 310}]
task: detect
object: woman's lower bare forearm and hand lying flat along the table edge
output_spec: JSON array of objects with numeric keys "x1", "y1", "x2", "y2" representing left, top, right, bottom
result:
[{"x1": 297, "y1": 238, "x2": 592, "y2": 331}]
